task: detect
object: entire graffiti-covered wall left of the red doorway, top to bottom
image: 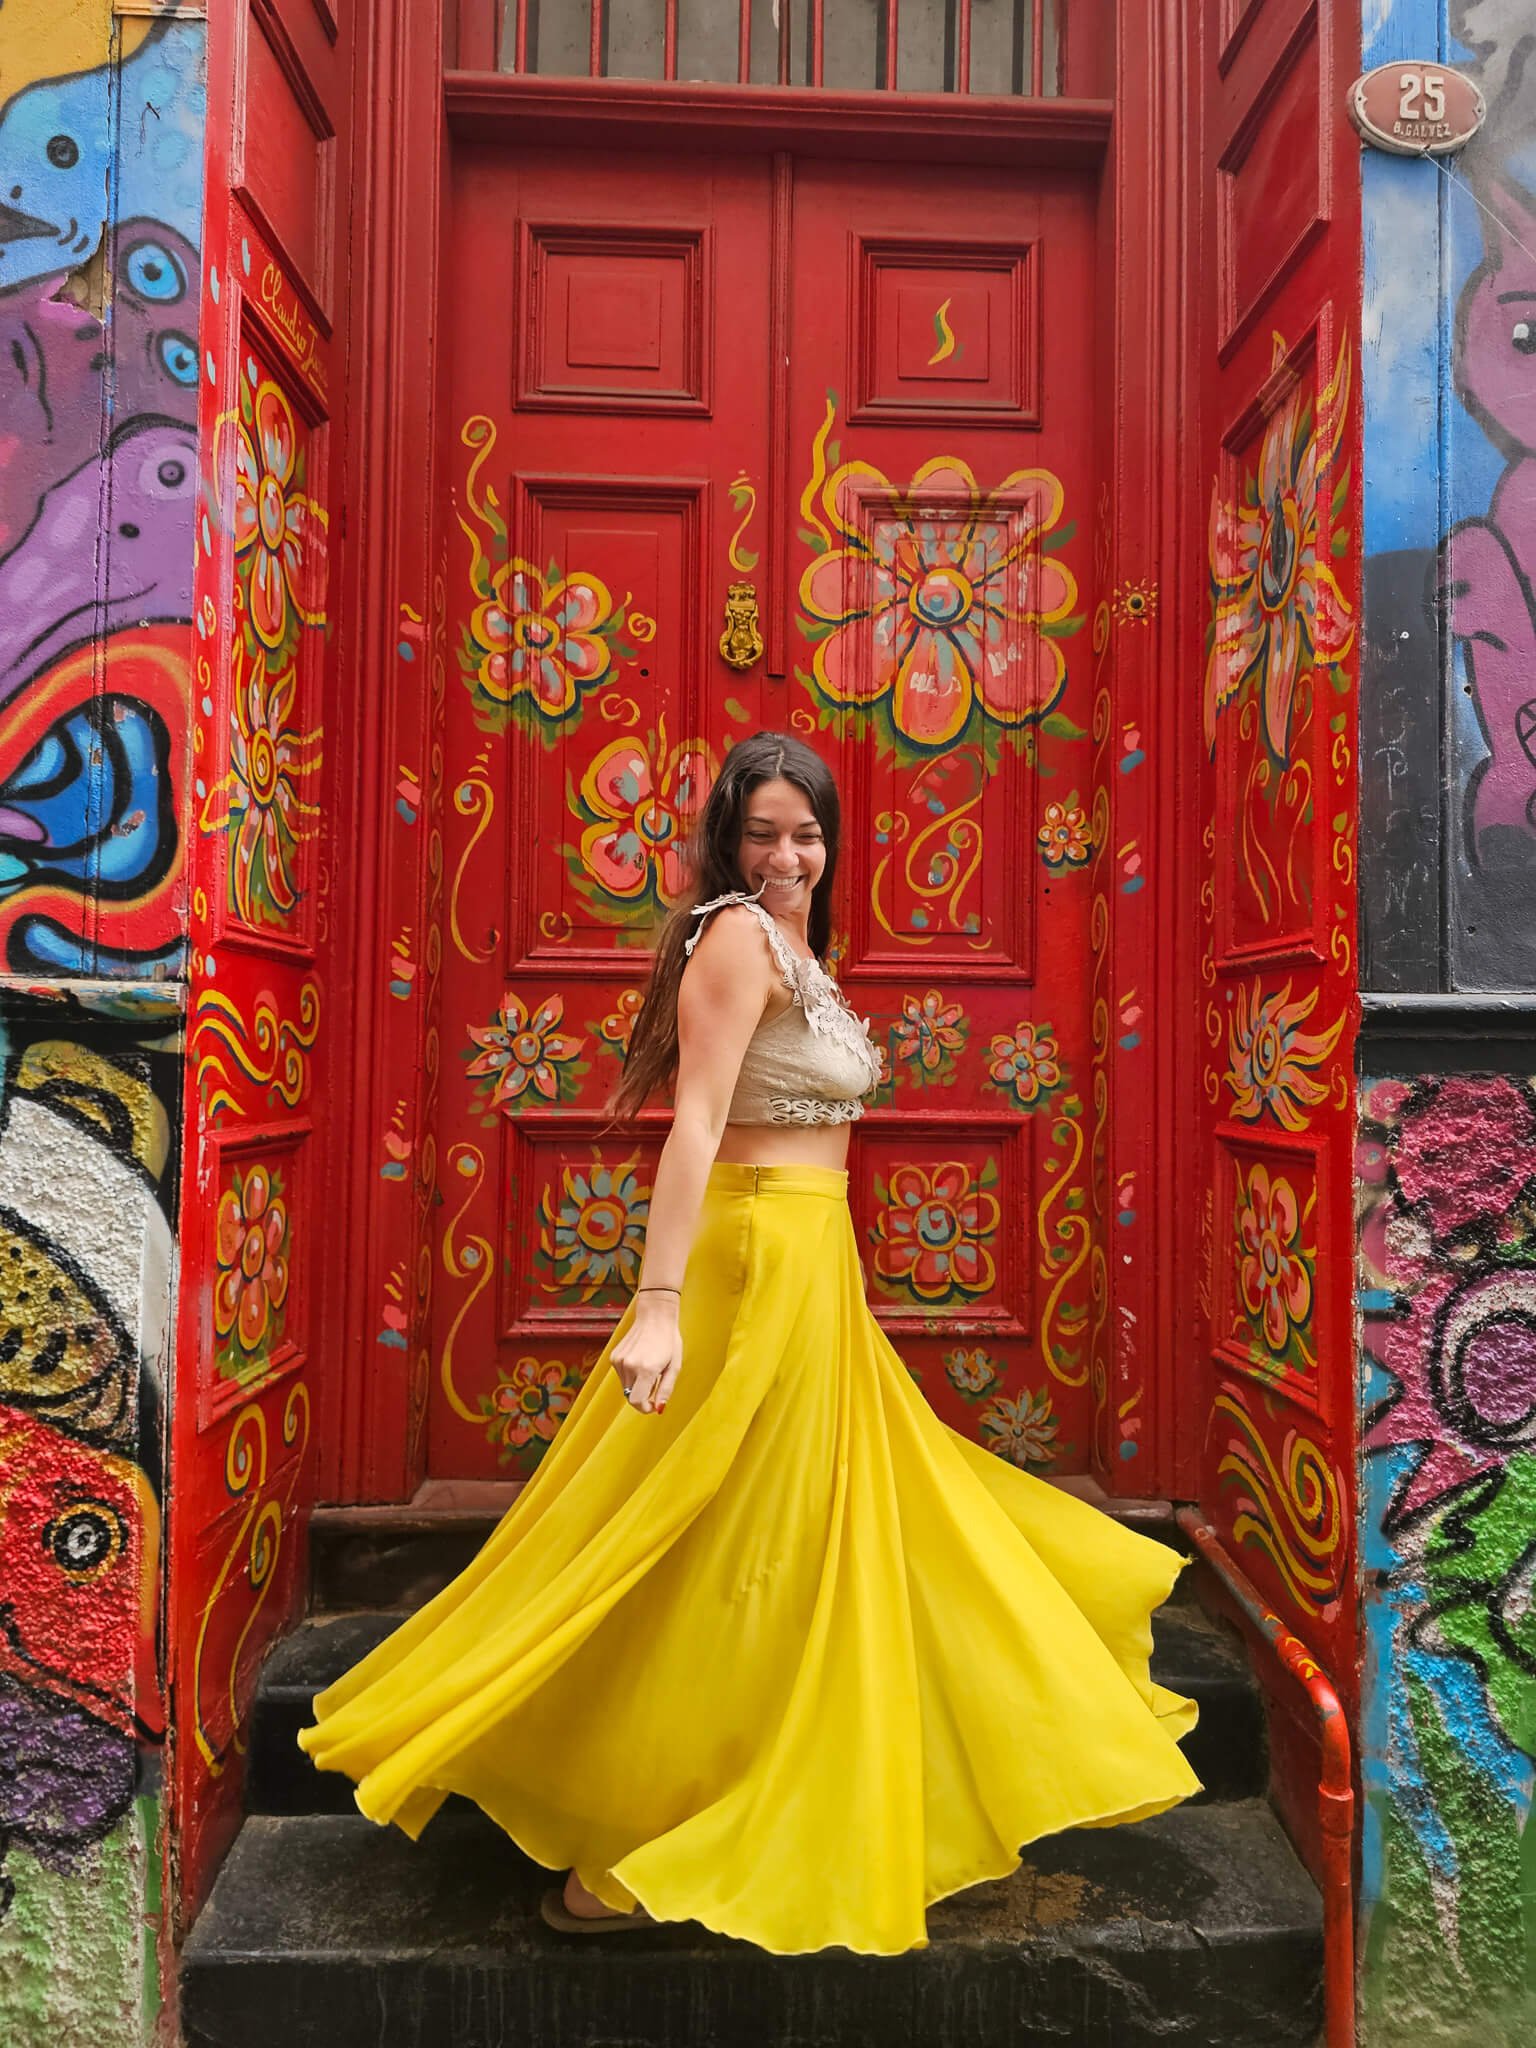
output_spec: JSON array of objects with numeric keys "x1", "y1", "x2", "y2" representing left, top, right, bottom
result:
[{"x1": 0, "y1": 0, "x2": 205, "y2": 2044}]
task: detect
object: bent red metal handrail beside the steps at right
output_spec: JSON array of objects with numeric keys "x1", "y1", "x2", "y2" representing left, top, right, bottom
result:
[{"x1": 1176, "y1": 1507, "x2": 1354, "y2": 2048}]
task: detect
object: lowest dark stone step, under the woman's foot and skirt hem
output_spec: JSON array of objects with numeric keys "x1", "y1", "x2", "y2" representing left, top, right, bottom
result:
[{"x1": 180, "y1": 1800, "x2": 1323, "y2": 2048}]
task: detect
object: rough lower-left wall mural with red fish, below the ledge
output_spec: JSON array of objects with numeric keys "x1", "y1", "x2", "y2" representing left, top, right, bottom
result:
[{"x1": 0, "y1": 991, "x2": 180, "y2": 2040}]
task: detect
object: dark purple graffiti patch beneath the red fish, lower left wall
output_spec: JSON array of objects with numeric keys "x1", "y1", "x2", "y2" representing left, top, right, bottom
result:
[{"x1": 0, "y1": 1671, "x2": 137, "y2": 1917}]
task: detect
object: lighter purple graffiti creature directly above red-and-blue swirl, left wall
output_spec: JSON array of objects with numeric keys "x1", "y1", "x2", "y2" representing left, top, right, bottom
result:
[{"x1": 0, "y1": 418, "x2": 197, "y2": 705}]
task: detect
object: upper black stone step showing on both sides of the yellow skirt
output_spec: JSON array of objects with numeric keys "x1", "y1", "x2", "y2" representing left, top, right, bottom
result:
[{"x1": 246, "y1": 1604, "x2": 1266, "y2": 1812}]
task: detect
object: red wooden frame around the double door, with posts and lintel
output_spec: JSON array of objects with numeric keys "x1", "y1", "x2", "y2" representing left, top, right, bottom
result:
[{"x1": 325, "y1": 0, "x2": 1204, "y2": 1505}]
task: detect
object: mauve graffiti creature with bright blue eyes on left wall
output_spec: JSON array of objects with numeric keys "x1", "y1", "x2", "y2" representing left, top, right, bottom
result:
[{"x1": 0, "y1": 221, "x2": 199, "y2": 561}]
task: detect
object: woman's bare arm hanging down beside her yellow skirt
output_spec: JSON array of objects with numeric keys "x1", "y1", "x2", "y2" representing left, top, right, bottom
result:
[{"x1": 610, "y1": 903, "x2": 774, "y2": 1415}]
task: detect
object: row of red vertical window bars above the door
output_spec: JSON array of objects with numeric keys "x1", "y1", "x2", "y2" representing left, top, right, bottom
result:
[{"x1": 502, "y1": 0, "x2": 1065, "y2": 100}]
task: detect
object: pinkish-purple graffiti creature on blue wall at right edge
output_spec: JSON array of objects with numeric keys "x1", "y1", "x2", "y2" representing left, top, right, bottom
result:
[{"x1": 1442, "y1": 172, "x2": 1536, "y2": 860}]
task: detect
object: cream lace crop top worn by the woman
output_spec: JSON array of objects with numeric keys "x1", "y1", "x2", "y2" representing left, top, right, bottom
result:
[{"x1": 684, "y1": 889, "x2": 881, "y2": 1124}]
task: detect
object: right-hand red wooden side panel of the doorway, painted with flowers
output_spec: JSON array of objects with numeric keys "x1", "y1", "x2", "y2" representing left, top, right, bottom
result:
[{"x1": 1192, "y1": 0, "x2": 1360, "y2": 1833}]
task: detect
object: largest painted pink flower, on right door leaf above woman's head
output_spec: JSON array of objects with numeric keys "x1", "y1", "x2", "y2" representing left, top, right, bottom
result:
[{"x1": 799, "y1": 399, "x2": 1081, "y2": 764}]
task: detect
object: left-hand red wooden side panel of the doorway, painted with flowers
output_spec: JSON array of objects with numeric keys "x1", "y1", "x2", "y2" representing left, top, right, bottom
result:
[{"x1": 170, "y1": 0, "x2": 356, "y2": 1909}]
